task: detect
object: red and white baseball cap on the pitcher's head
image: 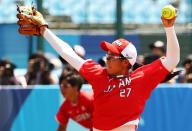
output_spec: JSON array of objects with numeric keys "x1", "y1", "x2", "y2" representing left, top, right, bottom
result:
[{"x1": 100, "y1": 39, "x2": 137, "y2": 66}]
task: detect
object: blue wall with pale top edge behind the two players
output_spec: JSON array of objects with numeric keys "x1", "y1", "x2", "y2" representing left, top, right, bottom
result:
[{"x1": 0, "y1": 84, "x2": 192, "y2": 131}]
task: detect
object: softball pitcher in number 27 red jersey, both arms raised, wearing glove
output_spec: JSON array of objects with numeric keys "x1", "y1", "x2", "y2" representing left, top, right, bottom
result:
[{"x1": 17, "y1": 6, "x2": 180, "y2": 131}]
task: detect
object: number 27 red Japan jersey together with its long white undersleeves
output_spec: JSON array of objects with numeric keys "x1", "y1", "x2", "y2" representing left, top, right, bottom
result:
[{"x1": 43, "y1": 27, "x2": 180, "y2": 130}]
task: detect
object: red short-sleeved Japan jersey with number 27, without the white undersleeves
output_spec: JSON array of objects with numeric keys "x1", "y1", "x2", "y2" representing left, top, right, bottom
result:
[{"x1": 80, "y1": 59, "x2": 169, "y2": 130}]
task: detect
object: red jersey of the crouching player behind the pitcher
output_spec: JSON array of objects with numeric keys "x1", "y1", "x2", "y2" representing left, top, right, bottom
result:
[{"x1": 56, "y1": 92, "x2": 93, "y2": 131}]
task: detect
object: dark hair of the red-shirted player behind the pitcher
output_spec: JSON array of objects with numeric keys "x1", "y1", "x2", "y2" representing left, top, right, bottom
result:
[{"x1": 59, "y1": 72, "x2": 83, "y2": 91}]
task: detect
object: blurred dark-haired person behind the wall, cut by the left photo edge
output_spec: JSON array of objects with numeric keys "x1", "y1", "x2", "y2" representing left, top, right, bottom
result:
[{"x1": 0, "y1": 60, "x2": 20, "y2": 85}]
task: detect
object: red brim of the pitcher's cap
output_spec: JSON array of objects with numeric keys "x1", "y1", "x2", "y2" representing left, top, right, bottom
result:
[{"x1": 100, "y1": 41, "x2": 120, "y2": 55}]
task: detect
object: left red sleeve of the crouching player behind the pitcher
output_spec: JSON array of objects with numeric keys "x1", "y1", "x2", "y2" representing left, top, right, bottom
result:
[{"x1": 56, "y1": 103, "x2": 69, "y2": 125}]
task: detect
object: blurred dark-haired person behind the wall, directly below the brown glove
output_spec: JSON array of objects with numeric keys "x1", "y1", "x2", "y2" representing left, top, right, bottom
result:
[{"x1": 24, "y1": 53, "x2": 57, "y2": 85}]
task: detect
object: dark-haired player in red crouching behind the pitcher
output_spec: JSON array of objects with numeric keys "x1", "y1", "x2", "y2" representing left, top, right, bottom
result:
[{"x1": 56, "y1": 71, "x2": 93, "y2": 131}]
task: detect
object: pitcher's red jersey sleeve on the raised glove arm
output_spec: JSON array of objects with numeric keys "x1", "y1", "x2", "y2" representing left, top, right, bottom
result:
[{"x1": 79, "y1": 60, "x2": 105, "y2": 84}]
